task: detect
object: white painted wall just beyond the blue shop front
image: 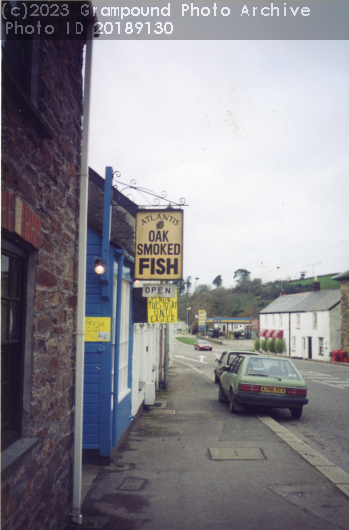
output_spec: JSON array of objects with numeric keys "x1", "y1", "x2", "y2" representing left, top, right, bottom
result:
[{"x1": 131, "y1": 324, "x2": 160, "y2": 416}]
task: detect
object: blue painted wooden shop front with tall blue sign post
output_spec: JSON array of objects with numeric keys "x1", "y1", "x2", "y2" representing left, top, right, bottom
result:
[{"x1": 83, "y1": 168, "x2": 134, "y2": 457}]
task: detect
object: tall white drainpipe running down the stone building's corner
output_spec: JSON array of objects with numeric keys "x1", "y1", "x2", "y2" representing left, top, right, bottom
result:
[{"x1": 72, "y1": 16, "x2": 93, "y2": 525}]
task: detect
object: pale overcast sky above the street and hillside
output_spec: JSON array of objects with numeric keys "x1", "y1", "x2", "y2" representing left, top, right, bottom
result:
[{"x1": 89, "y1": 41, "x2": 349, "y2": 287}]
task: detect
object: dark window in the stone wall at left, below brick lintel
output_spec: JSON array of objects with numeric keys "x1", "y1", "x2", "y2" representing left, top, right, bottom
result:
[{"x1": 1, "y1": 242, "x2": 27, "y2": 450}]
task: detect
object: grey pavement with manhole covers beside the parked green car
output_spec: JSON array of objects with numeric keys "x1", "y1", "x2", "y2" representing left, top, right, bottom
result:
[{"x1": 65, "y1": 361, "x2": 349, "y2": 530}]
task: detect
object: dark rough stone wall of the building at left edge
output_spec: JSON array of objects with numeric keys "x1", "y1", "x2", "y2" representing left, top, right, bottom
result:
[{"x1": 2, "y1": 35, "x2": 83, "y2": 530}]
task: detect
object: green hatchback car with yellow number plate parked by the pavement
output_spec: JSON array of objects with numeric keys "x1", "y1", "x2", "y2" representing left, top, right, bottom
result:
[{"x1": 218, "y1": 355, "x2": 308, "y2": 418}]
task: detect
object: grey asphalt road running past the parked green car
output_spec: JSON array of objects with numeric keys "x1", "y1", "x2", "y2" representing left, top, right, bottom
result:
[{"x1": 174, "y1": 332, "x2": 349, "y2": 473}]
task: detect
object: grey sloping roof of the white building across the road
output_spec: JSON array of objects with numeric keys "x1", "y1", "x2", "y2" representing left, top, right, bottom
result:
[{"x1": 260, "y1": 289, "x2": 341, "y2": 313}]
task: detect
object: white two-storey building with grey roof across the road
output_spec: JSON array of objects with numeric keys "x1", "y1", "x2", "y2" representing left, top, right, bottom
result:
[{"x1": 259, "y1": 282, "x2": 341, "y2": 361}]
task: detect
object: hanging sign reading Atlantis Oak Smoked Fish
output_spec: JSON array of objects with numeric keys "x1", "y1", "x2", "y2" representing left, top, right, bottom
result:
[{"x1": 135, "y1": 209, "x2": 183, "y2": 280}]
